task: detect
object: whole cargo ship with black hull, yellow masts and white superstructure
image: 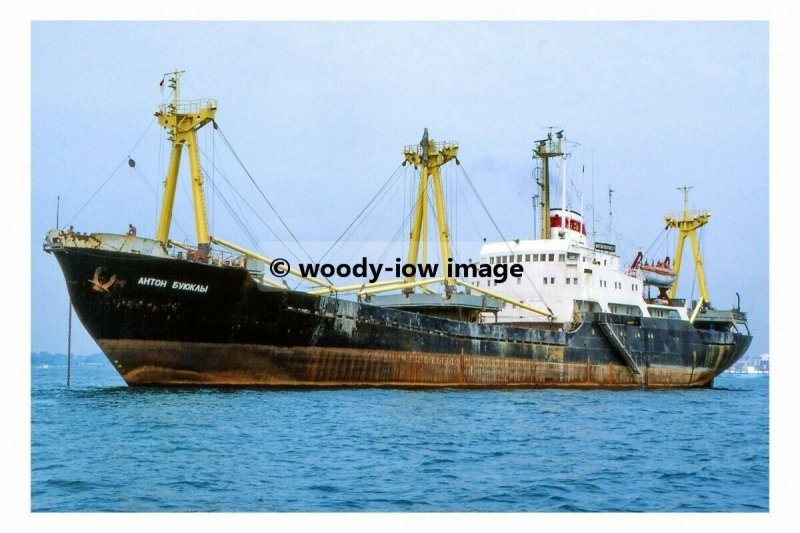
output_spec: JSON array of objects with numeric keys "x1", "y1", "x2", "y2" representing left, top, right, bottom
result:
[{"x1": 44, "y1": 71, "x2": 751, "y2": 389}]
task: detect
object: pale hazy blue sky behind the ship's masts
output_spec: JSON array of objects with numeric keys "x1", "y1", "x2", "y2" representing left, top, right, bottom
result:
[{"x1": 31, "y1": 21, "x2": 769, "y2": 354}]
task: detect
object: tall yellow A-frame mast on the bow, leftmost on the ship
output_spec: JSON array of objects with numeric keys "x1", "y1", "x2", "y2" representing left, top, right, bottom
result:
[{"x1": 156, "y1": 70, "x2": 217, "y2": 252}]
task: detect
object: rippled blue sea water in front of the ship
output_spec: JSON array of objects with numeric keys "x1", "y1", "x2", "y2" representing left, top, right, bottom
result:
[{"x1": 31, "y1": 363, "x2": 769, "y2": 512}]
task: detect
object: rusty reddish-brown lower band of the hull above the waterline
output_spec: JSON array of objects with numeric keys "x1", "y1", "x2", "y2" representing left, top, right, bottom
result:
[{"x1": 98, "y1": 340, "x2": 714, "y2": 389}]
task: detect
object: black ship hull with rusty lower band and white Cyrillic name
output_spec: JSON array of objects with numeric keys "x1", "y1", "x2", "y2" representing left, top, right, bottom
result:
[{"x1": 52, "y1": 247, "x2": 751, "y2": 388}]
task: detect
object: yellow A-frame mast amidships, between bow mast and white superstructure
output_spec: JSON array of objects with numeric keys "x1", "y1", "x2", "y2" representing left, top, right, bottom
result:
[{"x1": 403, "y1": 128, "x2": 458, "y2": 293}]
